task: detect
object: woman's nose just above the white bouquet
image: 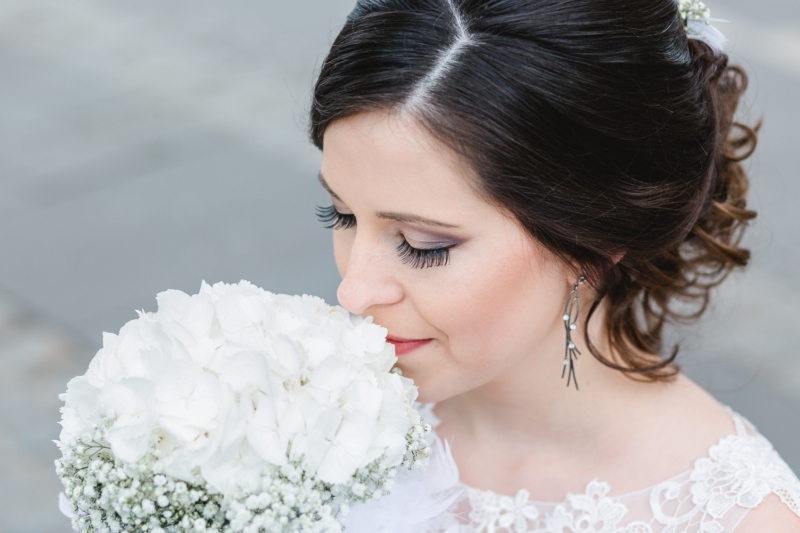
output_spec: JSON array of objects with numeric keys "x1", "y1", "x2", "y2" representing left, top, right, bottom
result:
[{"x1": 336, "y1": 232, "x2": 403, "y2": 315}]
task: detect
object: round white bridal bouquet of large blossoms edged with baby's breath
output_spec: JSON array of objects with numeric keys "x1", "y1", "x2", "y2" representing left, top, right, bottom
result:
[{"x1": 56, "y1": 281, "x2": 458, "y2": 533}]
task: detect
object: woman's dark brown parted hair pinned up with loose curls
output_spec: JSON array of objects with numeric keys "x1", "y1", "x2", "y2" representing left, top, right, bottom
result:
[{"x1": 310, "y1": 0, "x2": 756, "y2": 381}]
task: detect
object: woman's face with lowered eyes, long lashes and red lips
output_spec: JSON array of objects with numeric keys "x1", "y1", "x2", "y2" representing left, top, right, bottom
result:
[{"x1": 320, "y1": 112, "x2": 574, "y2": 402}]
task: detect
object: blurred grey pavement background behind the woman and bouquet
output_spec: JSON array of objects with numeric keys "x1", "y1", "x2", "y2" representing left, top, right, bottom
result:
[{"x1": 0, "y1": 0, "x2": 800, "y2": 533}]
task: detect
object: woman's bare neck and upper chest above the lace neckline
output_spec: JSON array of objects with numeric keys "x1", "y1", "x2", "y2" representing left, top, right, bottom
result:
[{"x1": 428, "y1": 300, "x2": 733, "y2": 501}]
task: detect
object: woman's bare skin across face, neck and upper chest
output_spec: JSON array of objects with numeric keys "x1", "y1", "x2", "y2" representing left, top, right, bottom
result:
[{"x1": 320, "y1": 112, "x2": 796, "y2": 515}]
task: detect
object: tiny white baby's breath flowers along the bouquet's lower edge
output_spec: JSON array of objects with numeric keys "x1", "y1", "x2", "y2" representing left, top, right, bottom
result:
[{"x1": 56, "y1": 424, "x2": 431, "y2": 533}]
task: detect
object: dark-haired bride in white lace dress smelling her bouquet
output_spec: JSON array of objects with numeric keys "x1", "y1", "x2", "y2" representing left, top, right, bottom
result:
[{"x1": 304, "y1": 0, "x2": 800, "y2": 533}]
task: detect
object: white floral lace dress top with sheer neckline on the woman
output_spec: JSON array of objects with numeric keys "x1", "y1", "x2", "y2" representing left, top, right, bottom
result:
[{"x1": 423, "y1": 406, "x2": 800, "y2": 533}]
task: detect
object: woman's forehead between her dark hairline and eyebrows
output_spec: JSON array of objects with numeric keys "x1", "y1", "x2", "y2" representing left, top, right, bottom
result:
[{"x1": 321, "y1": 112, "x2": 488, "y2": 209}]
